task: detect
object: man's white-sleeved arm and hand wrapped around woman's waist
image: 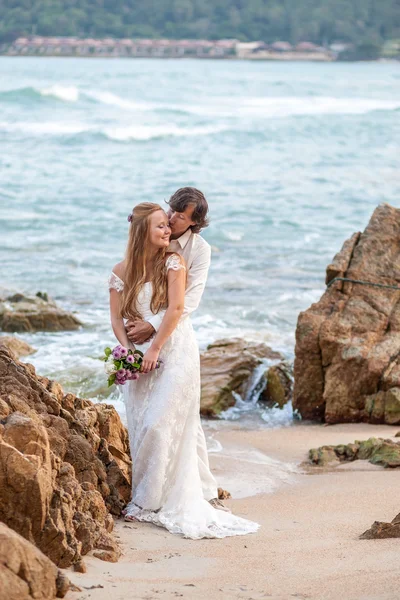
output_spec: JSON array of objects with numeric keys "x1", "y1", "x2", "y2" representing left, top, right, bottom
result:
[{"x1": 127, "y1": 240, "x2": 211, "y2": 344}]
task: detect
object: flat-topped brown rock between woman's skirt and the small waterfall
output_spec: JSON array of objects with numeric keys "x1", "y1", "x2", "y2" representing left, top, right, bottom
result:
[{"x1": 200, "y1": 338, "x2": 282, "y2": 417}]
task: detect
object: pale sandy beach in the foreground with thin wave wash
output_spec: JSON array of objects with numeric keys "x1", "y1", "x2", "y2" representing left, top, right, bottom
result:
[{"x1": 66, "y1": 424, "x2": 400, "y2": 600}]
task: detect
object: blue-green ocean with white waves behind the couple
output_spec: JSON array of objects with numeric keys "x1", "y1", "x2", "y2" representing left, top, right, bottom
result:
[{"x1": 0, "y1": 57, "x2": 400, "y2": 424}]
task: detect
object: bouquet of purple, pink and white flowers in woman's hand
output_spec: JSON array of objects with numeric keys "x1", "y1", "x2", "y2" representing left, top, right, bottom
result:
[{"x1": 102, "y1": 345, "x2": 161, "y2": 387}]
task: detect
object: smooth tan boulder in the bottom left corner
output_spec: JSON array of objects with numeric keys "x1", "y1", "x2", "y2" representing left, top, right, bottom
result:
[{"x1": 0, "y1": 523, "x2": 70, "y2": 600}]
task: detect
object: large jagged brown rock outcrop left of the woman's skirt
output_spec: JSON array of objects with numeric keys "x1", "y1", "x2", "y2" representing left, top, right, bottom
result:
[{"x1": 0, "y1": 347, "x2": 131, "y2": 567}]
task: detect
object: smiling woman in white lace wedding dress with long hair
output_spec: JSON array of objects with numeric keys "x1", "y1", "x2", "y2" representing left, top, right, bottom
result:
[{"x1": 109, "y1": 202, "x2": 258, "y2": 539}]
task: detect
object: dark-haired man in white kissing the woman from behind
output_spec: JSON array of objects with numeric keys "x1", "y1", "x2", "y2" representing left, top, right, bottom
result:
[{"x1": 126, "y1": 187, "x2": 229, "y2": 511}]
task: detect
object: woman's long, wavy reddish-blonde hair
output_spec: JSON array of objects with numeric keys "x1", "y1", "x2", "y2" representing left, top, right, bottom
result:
[{"x1": 120, "y1": 202, "x2": 168, "y2": 319}]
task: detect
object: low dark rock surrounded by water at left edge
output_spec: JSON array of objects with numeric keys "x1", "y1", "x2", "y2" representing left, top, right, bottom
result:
[{"x1": 0, "y1": 292, "x2": 82, "y2": 332}]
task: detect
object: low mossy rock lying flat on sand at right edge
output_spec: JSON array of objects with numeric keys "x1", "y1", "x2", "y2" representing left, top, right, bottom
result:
[{"x1": 308, "y1": 438, "x2": 400, "y2": 469}]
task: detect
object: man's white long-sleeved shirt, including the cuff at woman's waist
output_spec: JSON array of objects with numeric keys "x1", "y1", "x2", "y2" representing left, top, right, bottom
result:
[{"x1": 148, "y1": 228, "x2": 211, "y2": 331}]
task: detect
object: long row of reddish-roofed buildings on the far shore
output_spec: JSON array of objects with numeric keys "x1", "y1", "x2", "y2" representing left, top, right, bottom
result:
[{"x1": 0, "y1": 36, "x2": 335, "y2": 61}]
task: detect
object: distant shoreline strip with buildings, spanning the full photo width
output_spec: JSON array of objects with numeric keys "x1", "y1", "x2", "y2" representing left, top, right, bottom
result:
[{"x1": 0, "y1": 35, "x2": 400, "y2": 63}]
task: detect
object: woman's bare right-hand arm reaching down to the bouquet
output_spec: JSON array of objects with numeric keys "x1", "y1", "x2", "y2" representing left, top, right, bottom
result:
[{"x1": 141, "y1": 259, "x2": 186, "y2": 373}]
